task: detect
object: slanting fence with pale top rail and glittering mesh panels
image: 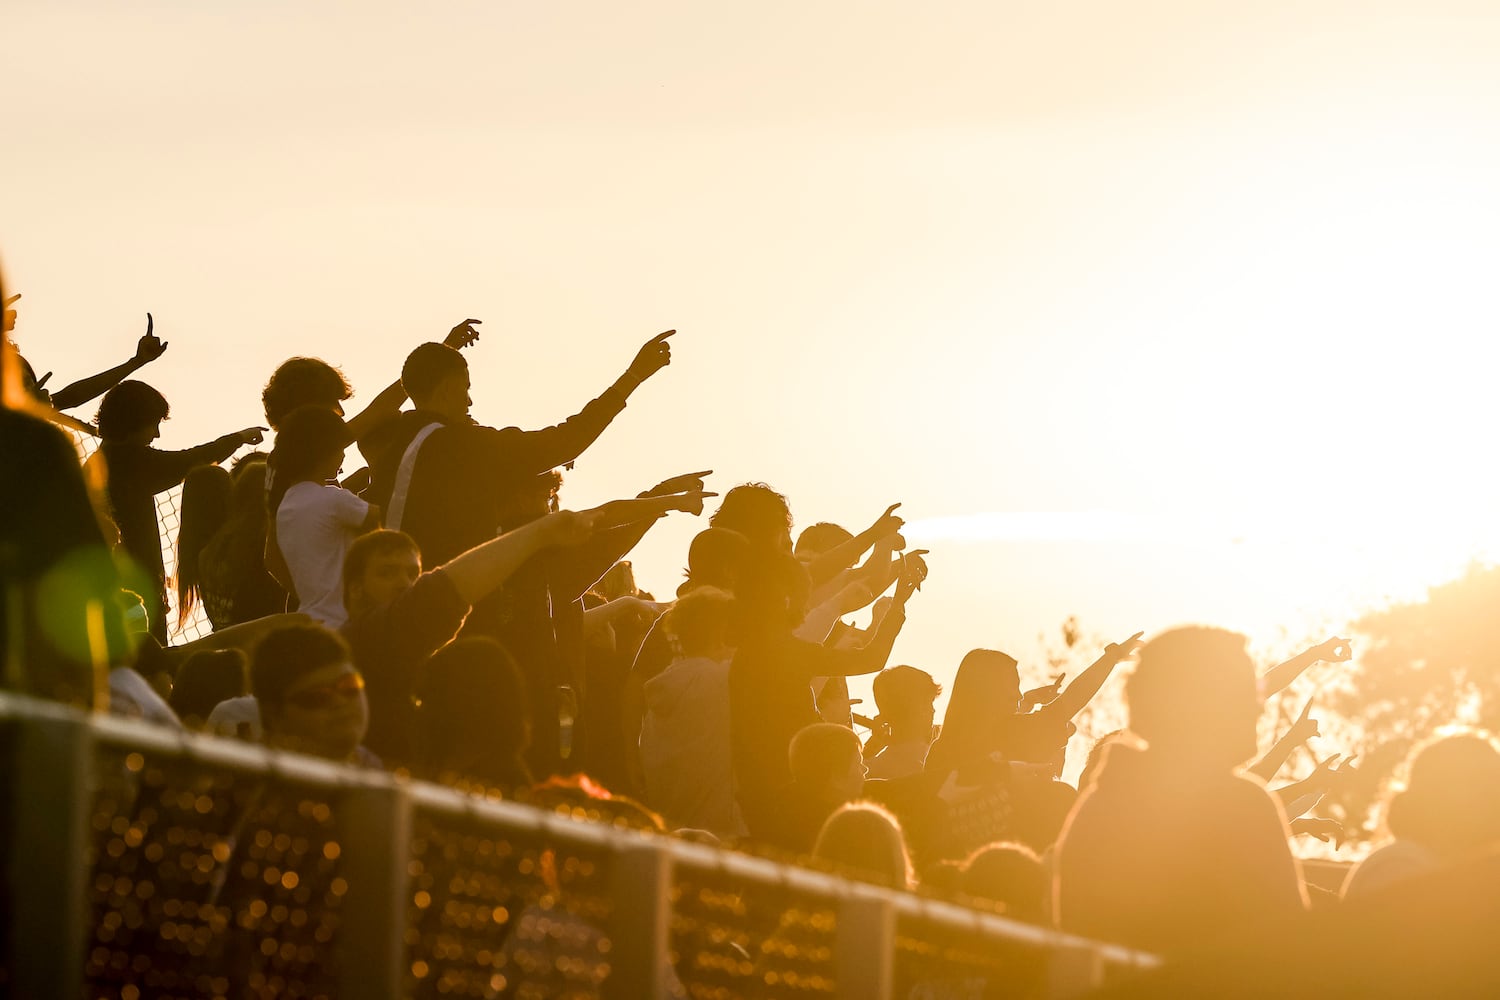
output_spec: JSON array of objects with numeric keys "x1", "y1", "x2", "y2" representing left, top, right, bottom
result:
[{"x1": 0, "y1": 694, "x2": 1155, "y2": 1000}]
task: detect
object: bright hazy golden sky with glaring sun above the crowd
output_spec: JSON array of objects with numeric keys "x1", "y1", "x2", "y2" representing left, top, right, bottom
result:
[{"x1": 0, "y1": 0, "x2": 1500, "y2": 704}]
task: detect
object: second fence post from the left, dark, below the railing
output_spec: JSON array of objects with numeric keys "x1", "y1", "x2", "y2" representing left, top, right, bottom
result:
[{"x1": 335, "y1": 781, "x2": 411, "y2": 1000}]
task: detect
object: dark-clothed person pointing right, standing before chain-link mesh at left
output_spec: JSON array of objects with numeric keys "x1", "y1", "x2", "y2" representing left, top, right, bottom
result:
[{"x1": 89, "y1": 379, "x2": 266, "y2": 645}]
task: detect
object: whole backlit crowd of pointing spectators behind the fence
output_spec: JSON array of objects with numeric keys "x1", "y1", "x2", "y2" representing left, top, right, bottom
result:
[{"x1": 0, "y1": 289, "x2": 1500, "y2": 983}]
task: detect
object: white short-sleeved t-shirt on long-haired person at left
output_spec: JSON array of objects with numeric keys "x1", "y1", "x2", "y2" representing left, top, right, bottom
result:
[{"x1": 276, "y1": 483, "x2": 371, "y2": 630}]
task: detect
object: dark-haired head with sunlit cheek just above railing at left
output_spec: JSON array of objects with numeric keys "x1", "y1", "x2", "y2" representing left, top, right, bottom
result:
[{"x1": 251, "y1": 625, "x2": 369, "y2": 760}]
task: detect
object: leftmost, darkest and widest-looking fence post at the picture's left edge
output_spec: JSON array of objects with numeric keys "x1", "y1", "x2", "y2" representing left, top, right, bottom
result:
[{"x1": 5, "y1": 715, "x2": 93, "y2": 997}]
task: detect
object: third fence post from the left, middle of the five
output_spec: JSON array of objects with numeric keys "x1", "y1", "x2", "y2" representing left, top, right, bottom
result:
[{"x1": 605, "y1": 840, "x2": 672, "y2": 1000}]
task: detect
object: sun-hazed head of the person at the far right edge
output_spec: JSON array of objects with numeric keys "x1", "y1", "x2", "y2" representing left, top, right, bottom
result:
[{"x1": 1386, "y1": 732, "x2": 1500, "y2": 856}]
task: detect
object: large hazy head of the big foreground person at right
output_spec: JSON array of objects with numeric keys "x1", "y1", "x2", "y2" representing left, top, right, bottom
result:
[{"x1": 1125, "y1": 625, "x2": 1262, "y2": 768}]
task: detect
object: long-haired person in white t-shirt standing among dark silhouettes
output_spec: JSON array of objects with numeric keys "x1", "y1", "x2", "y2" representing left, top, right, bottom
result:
[{"x1": 267, "y1": 406, "x2": 380, "y2": 630}]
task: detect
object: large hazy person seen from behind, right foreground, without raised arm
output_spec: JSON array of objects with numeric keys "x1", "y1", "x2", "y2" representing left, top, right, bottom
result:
[{"x1": 1050, "y1": 628, "x2": 1307, "y2": 954}]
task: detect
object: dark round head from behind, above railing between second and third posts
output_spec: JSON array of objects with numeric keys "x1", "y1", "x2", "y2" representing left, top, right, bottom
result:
[{"x1": 417, "y1": 639, "x2": 531, "y2": 789}]
